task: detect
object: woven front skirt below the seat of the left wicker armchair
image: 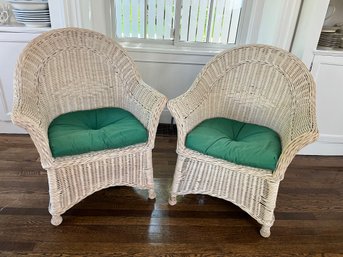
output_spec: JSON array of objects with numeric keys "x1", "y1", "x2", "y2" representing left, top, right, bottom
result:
[{"x1": 47, "y1": 149, "x2": 154, "y2": 215}]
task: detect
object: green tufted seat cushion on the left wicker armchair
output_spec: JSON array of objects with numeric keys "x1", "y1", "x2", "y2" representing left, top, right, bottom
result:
[{"x1": 48, "y1": 108, "x2": 148, "y2": 157}]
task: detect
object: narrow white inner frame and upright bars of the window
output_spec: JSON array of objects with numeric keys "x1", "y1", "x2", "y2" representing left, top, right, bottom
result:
[{"x1": 110, "y1": 0, "x2": 255, "y2": 50}]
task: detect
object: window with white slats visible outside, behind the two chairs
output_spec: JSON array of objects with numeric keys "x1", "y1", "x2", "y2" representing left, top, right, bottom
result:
[{"x1": 114, "y1": 0, "x2": 244, "y2": 44}]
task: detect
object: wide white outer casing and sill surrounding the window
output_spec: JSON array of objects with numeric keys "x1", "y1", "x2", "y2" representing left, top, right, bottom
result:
[{"x1": 49, "y1": 0, "x2": 302, "y2": 55}]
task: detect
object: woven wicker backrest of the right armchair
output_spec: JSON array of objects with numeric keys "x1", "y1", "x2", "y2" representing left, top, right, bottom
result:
[{"x1": 177, "y1": 45, "x2": 316, "y2": 150}]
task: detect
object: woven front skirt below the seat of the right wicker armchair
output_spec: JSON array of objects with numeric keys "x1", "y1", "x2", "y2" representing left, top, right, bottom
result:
[{"x1": 172, "y1": 155, "x2": 280, "y2": 226}]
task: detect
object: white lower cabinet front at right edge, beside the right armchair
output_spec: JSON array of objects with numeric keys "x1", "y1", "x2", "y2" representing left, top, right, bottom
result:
[{"x1": 303, "y1": 52, "x2": 343, "y2": 155}]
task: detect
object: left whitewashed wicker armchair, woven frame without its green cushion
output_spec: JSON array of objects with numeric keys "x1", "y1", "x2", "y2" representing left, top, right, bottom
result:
[{"x1": 12, "y1": 28, "x2": 167, "y2": 226}]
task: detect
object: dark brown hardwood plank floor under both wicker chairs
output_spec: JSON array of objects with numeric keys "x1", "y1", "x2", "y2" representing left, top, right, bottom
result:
[{"x1": 0, "y1": 135, "x2": 343, "y2": 257}]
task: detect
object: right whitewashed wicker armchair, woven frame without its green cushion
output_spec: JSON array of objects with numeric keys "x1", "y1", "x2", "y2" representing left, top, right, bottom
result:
[{"x1": 168, "y1": 45, "x2": 318, "y2": 237}]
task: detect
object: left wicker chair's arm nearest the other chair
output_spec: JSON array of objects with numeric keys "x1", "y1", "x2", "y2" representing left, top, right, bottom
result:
[{"x1": 126, "y1": 79, "x2": 168, "y2": 148}]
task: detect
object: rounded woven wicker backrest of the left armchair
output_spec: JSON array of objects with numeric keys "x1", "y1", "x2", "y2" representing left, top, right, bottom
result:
[{"x1": 15, "y1": 29, "x2": 146, "y2": 125}]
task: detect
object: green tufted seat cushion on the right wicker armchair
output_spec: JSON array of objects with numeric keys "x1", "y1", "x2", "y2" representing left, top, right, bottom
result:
[{"x1": 186, "y1": 118, "x2": 281, "y2": 170}]
